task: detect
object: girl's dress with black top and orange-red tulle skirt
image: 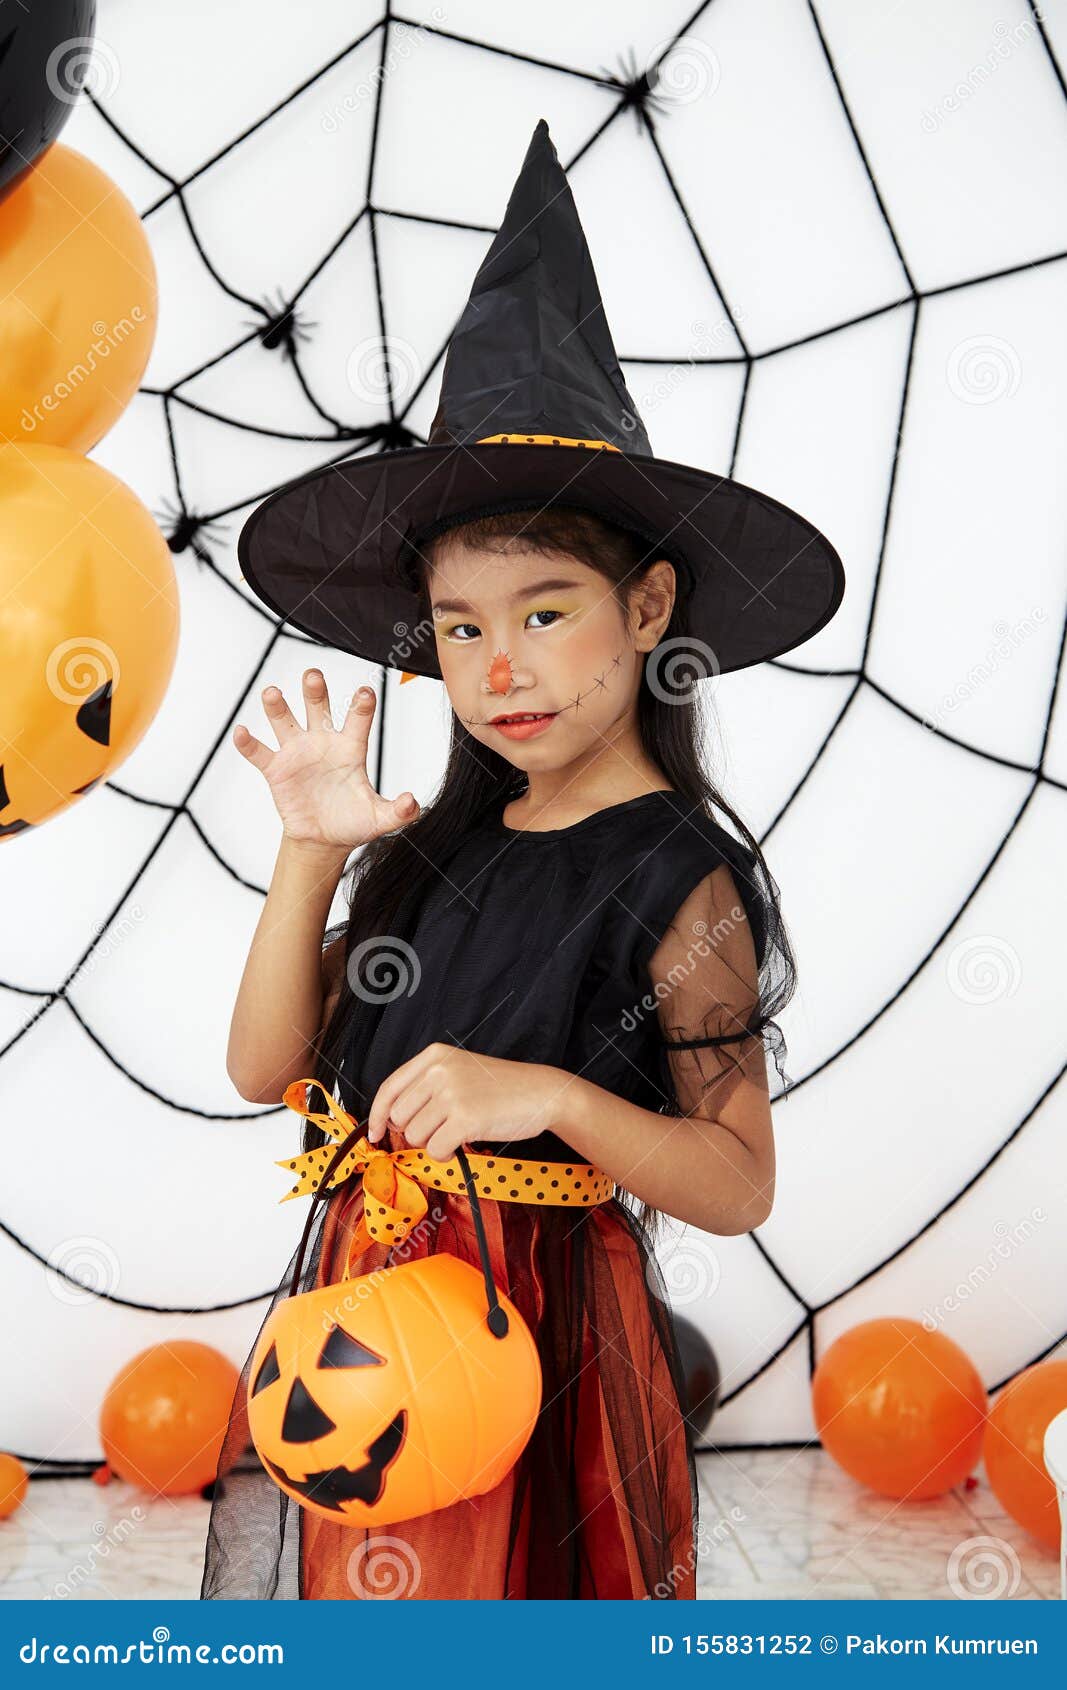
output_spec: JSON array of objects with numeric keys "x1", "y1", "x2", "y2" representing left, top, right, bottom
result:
[{"x1": 201, "y1": 791, "x2": 777, "y2": 1599}]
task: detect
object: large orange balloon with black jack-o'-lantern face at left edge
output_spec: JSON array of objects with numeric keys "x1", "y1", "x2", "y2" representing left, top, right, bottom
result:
[{"x1": 0, "y1": 446, "x2": 179, "y2": 840}]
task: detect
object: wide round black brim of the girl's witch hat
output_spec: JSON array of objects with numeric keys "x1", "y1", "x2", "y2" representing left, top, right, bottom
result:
[{"x1": 237, "y1": 443, "x2": 845, "y2": 679}]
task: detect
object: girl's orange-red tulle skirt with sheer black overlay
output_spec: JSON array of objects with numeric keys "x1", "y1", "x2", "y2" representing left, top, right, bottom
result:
[{"x1": 201, "y1": 1181, "x2": 697, "y2": 1600}]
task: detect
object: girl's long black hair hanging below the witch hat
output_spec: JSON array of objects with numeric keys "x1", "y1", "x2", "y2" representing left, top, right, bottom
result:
[{"x1": 304, "y1": 505, "x2": 796, "y2": 1227}]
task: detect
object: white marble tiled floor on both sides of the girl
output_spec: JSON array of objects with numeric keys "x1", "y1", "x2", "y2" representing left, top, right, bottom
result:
[{"x1": 0, "y1": 1450, "x2": 1060, "y2": 1600}]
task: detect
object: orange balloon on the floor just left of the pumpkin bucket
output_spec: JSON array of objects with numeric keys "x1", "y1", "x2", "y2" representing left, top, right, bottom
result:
[{"x1": 100, "y1": 1338, "x2": 240, "y2": 1496}]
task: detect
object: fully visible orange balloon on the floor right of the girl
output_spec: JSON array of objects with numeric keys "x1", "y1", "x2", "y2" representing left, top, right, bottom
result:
[{"x1": 812, "y1": 1317, "x2": 988, "y2": 1501}]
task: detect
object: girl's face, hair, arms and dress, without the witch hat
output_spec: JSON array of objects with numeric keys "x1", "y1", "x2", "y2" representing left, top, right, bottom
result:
[{"x1": 201, "y1": 507, "x2": 793, "y2": 1599}]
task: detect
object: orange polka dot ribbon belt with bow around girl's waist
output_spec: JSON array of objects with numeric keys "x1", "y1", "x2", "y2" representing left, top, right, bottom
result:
[{"x1": 277, "y1": 1080, "x2": 616, "y2": 1254}]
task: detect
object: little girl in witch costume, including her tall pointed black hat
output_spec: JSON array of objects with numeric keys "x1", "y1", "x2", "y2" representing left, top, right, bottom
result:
[{"x1": 201, "y1": 120, "x2": 844, "y2": 1600}]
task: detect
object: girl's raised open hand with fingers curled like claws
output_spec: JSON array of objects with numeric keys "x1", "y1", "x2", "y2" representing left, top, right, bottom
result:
[{"x1": 233, "y1": 669, "x2": 419, "y2": 850}]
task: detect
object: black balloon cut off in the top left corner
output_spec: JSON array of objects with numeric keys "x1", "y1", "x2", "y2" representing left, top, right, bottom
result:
[{"x1": 0, "y1": 0, "x2": 96, "y2": 199}]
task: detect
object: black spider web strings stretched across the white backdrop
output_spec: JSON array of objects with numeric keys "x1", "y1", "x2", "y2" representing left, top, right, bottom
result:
[{"x1": 0, "y1": 0, "x2": 1067, "y2": 1479}]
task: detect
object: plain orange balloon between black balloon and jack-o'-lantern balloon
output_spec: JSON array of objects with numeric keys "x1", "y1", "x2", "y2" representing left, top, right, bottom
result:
[{"x1": 0, "y1": 142, "x2": 157, "y2": 451}]
